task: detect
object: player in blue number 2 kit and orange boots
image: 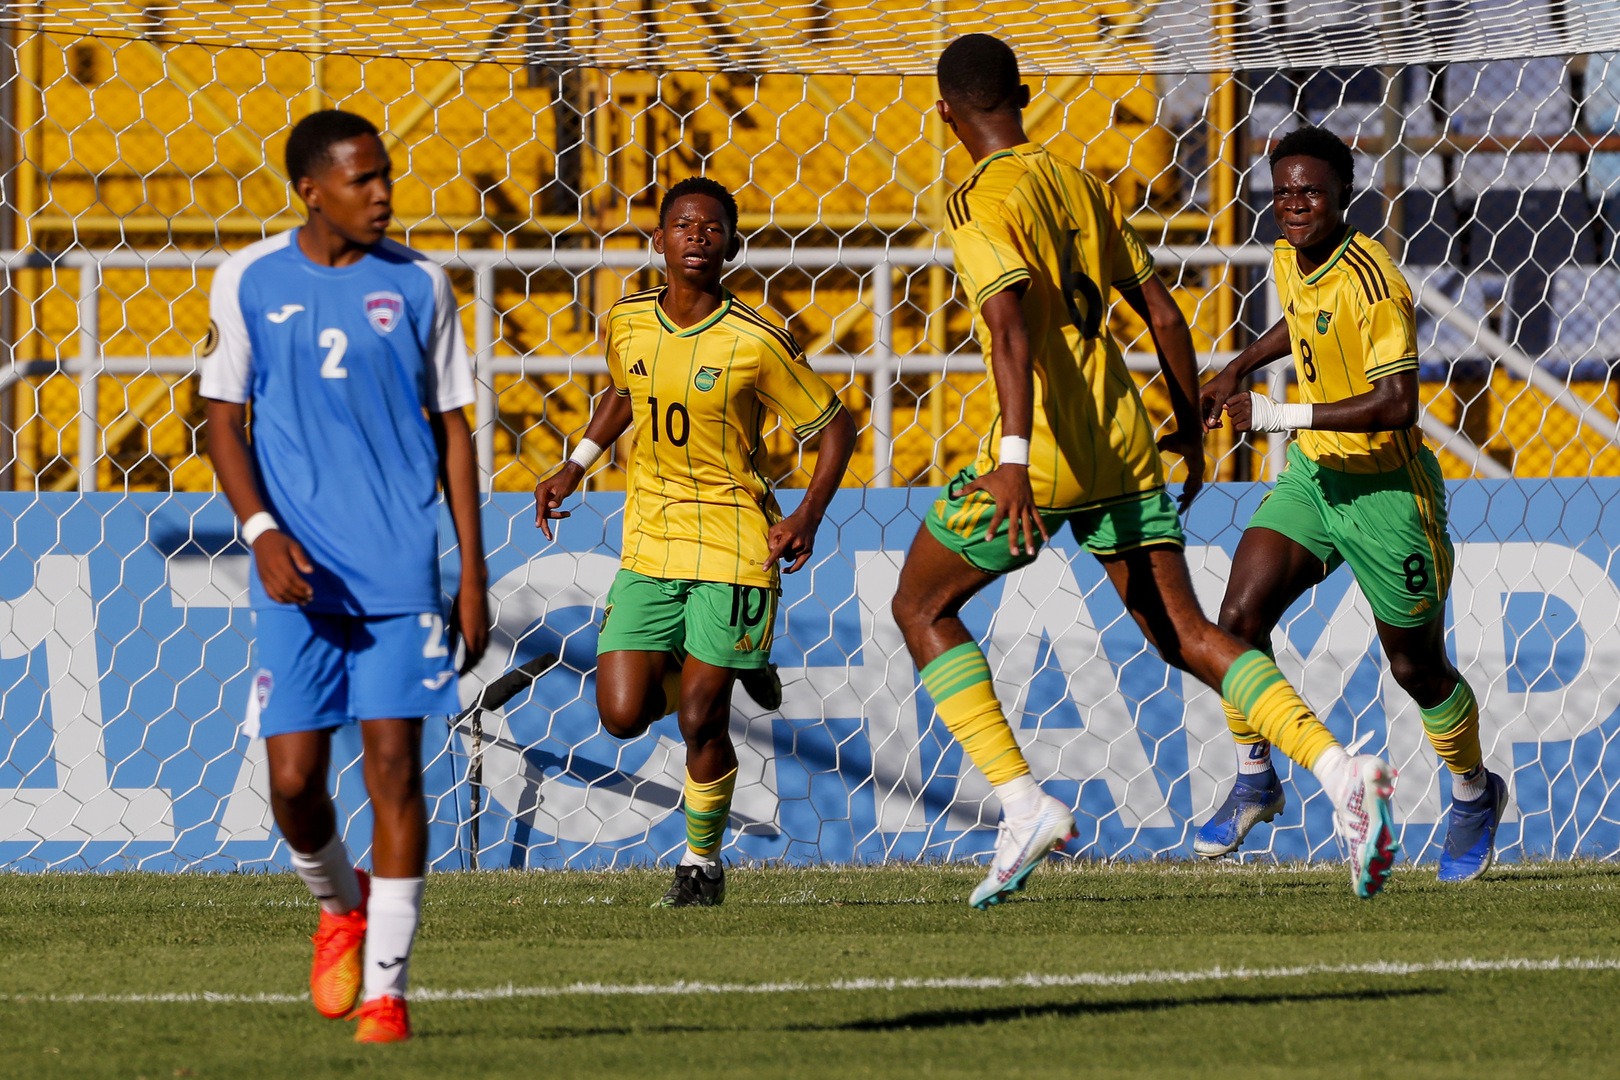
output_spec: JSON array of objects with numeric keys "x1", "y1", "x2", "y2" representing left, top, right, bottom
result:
[{"x1": 201, "y1": 110, "x2": 489, "y2": 1043}]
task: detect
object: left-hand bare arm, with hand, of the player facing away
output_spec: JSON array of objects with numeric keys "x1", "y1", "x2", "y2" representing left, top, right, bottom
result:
[{"x1": 962, "y1": 287, "x2": 1051, "y2": 555}]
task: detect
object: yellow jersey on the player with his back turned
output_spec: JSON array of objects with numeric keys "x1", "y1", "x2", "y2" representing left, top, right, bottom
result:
[{"x1": 946, "y1": 142, "x2": 1165, "y2": 510}]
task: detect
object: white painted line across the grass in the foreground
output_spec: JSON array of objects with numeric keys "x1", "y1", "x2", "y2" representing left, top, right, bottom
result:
[{"x1": 12, "y1": 957, "x2": 1620, "y2": 1006}]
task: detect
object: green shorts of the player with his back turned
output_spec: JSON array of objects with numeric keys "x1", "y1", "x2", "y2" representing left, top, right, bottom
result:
[{"x1": 927, "y1": 466, "x2": 1187, "y2": 573}]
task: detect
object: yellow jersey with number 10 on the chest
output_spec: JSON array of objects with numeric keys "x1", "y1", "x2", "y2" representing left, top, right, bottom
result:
[{"x1": 608, "y1": 288, "x2": 841, "y2": 588}]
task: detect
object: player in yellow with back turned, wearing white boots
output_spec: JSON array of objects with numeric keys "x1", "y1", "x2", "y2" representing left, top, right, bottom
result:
[{"x1": 894, "y1": 34, "x2": 1396, "y2": 907}]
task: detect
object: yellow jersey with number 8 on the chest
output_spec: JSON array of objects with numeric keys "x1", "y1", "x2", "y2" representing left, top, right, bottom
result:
[{"x1": 1272, "y1": 228, "x2": 1422, "y2": 473}]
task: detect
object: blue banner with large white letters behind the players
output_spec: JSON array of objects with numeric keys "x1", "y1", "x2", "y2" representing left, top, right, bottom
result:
[{"x1": 0, "y1": 479, "x2": 1620, "y2": 870}]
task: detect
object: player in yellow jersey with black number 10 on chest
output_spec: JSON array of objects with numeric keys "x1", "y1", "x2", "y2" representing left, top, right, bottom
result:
[{"x1": 535, "y1": 178, "x2": 855, "y2": 907}]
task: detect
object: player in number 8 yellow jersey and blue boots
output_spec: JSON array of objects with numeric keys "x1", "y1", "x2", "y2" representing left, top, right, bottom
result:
[{"x1": 1194, "y1": 128, "x2": 1507, "y2": 881}]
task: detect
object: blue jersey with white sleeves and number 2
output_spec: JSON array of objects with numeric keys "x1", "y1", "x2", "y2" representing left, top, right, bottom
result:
[{"x1": 201, "y1": 230, "x2": 473, "y2": 615}]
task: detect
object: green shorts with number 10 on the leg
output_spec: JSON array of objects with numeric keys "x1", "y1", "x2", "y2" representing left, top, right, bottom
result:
[{"x1": 596, "y1": 570, "x2": 781, "y2": 669}]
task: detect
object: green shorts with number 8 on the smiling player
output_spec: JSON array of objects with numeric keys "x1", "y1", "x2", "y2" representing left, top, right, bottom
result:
[{"x1": 1249, "y1": 444, "x2": 1453, "y2": 627}]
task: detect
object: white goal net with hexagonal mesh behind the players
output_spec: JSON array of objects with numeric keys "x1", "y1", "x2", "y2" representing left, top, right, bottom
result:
[{"x1": 0, "y1": 0, "x2": 1620, "y2": 870}]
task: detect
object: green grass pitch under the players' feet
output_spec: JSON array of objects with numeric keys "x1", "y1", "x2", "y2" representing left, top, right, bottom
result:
[{"x1": 0, "y1": 863, "x2": 1620, "y2": 1080}]
